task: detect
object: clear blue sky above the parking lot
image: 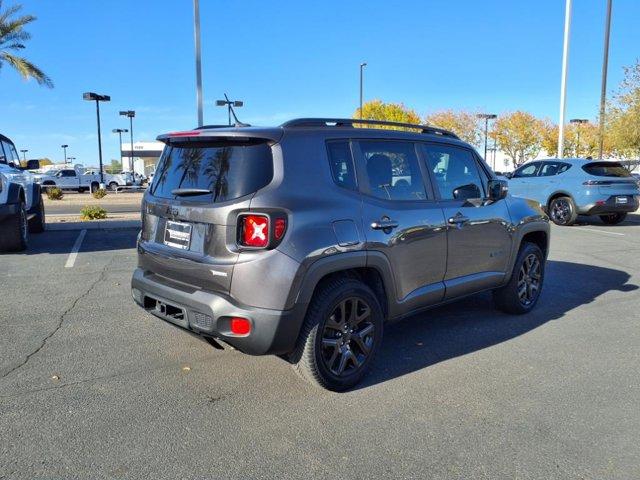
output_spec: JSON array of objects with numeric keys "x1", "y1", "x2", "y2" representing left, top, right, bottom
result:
[{"x1": 0, "y1": 0, "x2": 640, "y2": 165}]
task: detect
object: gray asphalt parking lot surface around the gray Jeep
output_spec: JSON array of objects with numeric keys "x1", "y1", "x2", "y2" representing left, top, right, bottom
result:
[{"x1": 0, "y1": 217, "x2": 640, "y2": 479}]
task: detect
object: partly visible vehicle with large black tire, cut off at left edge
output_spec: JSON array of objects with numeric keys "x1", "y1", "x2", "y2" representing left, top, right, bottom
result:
[{"x1": 0, "y1": 135, "x2": 45, "y2": 251}]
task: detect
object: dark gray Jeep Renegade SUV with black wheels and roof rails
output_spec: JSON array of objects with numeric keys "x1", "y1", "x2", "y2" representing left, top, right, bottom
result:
[{"x1": 132, "y1": 119, "x2": 549, "y2": 390}]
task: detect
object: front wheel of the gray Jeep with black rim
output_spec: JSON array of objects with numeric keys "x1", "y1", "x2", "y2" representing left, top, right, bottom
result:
[{"x1": 493, "y1": 242, "x2": 544, "y2": 315}]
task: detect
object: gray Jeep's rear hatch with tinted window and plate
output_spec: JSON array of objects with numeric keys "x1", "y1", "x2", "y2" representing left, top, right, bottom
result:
[{"x1": 139, "y1": 134, "x2": 274, "y2": 293}]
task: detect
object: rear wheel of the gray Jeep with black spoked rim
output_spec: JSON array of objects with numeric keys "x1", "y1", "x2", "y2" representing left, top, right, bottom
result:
[{"x1": 289, "y1": 278, "x2": 384, "y2": 391}]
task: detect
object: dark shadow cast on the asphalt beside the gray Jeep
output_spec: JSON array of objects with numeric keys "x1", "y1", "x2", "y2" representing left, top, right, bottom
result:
[{"x1": 355, "y1": 261, "x2": 638, "y2": 390}]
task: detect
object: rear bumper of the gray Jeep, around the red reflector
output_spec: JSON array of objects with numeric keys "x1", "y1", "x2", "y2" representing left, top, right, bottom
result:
[{"x1": 131, "y1": 268, "x2": 303, "y2": 355}]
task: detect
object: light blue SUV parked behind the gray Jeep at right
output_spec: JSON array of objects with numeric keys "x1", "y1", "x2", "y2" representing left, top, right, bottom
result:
[{"x1": 509, "y1": 158, "x2": 640, "y2": 225}]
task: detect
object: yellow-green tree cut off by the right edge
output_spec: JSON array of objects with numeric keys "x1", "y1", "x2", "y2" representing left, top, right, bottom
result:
[{"x1": 605, "y1": 61, "x2": 640, "y2": 158}]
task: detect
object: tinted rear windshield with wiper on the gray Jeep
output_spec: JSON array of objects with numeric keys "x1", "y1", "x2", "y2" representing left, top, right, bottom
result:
[{"x1": 152, "y1": 142, "x2": 273, "y2": 203}]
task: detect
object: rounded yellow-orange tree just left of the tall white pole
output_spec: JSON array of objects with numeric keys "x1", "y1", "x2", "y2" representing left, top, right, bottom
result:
[{"x1": 489, "y1": 111, "x2": 546, "y2": 168}]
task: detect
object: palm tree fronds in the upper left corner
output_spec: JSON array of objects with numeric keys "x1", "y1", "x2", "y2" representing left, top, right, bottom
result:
[{"x1": 0, "y1": 0, "x2": 53, "y2": 88}]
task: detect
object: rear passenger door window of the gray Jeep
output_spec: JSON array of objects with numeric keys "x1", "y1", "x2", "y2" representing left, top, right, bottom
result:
[{"x1": 359, "y1": 140, "x2": 427, "y2": 200}]
